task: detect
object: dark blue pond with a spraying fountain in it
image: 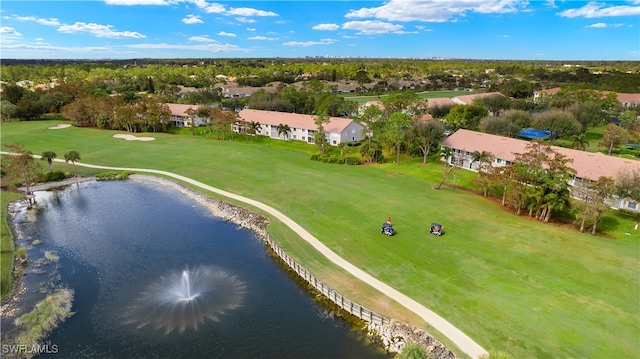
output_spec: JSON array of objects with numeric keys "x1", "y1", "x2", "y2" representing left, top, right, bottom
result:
[{"x1": 2, "y1": 181, "x2": 391, "y2": 358}]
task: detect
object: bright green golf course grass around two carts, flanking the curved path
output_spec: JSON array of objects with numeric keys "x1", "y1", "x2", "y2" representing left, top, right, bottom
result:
[{"x1": 1, "y1": 121, "x2": 640, "y2": 358}]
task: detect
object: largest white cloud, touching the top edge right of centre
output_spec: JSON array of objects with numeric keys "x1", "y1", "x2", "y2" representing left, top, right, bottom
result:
[{"x1": 345, "y1": 0, "x2": 528, "y2": 22}]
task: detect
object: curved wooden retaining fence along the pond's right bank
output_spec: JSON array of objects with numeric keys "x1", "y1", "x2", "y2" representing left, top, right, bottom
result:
[{"x1": 264, "y1": 233, "x2": 390, "y2": 326}]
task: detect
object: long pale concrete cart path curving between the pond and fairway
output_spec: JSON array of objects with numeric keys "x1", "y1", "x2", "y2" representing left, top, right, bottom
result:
[{"x1": 8, "y1": 152, "x2": 488, "y2": 358}]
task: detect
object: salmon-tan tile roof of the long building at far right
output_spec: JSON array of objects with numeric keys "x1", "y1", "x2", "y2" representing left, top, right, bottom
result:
[{"x1": 442, "y1": 130, "x2": 640, "y2": 181}]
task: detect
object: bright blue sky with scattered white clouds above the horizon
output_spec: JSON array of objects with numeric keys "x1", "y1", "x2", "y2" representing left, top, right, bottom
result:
[{"x1": 0, "y1": 0, "x2": 640, "y2": 60}]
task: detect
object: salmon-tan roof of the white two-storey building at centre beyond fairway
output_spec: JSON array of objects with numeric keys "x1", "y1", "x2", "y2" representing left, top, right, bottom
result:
[{"x1": 239, "y1": 109, "x2": 353, "y2": 133}]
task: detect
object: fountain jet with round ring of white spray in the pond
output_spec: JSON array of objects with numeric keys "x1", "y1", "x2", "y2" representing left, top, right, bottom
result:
[{"x1": 124, "y1": 266, "x2": 246, "y2": 334}]
